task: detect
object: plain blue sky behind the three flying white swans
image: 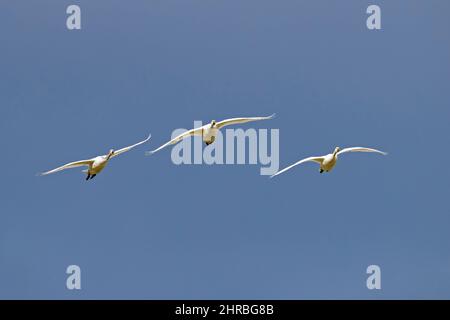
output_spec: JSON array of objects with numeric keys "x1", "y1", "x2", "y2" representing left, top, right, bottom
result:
[{"x1": 0, "y1": 0, "x2": 450, "y2": 299}]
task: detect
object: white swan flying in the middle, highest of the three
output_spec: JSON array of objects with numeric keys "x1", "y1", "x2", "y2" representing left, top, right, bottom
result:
[{"x1": 145, "y1": 113, "x2": 275, "y2": 155}]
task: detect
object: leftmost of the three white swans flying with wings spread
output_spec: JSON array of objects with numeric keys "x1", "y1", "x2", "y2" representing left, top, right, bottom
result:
[{"x1": 39, "y1": 135, "x2": 151, "y2": 180}]
